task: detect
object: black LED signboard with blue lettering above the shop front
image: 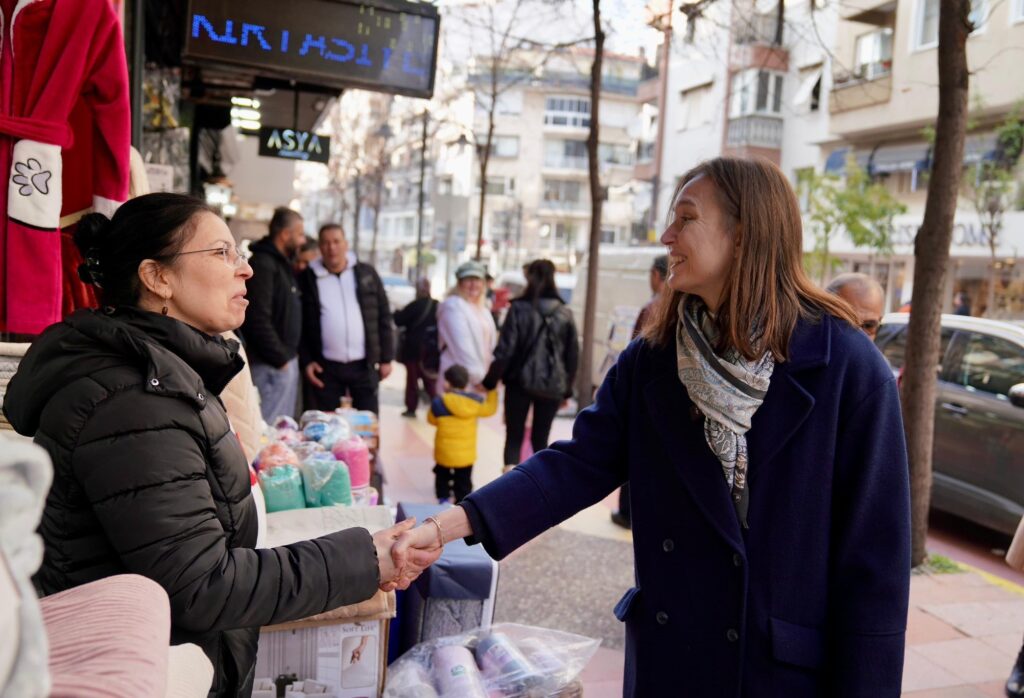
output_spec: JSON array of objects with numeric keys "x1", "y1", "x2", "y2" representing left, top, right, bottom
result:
[{"x1": 184, "y1": 0, "x2": 440, "y2": 97}]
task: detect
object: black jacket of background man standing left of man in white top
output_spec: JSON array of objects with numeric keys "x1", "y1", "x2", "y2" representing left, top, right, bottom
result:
[{"x1": 242, "y1": 237, "x2": 302, "y2": 368}]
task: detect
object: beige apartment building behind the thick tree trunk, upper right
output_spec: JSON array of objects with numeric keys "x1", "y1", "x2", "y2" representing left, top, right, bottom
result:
[{"x1": 822, "y1": 0, "x2": 1024, "y2": 317}]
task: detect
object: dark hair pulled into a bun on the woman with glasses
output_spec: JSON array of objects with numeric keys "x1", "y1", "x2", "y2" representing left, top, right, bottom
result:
[{"x1": 75, "y1": 193, "x2": 216, "y2": 306}]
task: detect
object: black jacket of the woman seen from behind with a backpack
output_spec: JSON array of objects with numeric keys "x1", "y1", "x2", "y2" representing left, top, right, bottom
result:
[{"x1": 483, "y1": 298, "x2": 580, "y2": 398}]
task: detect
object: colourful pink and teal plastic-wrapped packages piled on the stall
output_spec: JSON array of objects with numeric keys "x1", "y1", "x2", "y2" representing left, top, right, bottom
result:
[{"x1": 253, "y1": 408, "x2": 378, "y2": 514}]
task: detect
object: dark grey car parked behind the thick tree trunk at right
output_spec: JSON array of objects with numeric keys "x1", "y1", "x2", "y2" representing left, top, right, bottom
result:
[{"x1": 876, "y1": 313, "x2": 1024, "y2": 534}]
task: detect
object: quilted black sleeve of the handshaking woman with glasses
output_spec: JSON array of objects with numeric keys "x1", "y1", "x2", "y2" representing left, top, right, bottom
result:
[{"x1": 71, "y1": 399, "x2": 379, "y2": 632}]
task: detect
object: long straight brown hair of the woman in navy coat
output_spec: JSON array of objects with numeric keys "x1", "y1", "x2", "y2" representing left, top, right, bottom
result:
[{"x1": 643, "y1": 158, "x2": 858, "y2": 361}]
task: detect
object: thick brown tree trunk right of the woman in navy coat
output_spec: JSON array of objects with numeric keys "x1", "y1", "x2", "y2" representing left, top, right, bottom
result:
[{"x1": 902, "y1": 0, "x2": 971, "y2": 566}]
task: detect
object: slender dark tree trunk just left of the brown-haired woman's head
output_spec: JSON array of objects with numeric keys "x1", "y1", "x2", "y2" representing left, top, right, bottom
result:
[{"x1": 577, "y1": 0, "x2": 604, "y2": 409}]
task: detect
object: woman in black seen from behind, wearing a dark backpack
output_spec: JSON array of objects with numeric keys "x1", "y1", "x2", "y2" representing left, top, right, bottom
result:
[{"x1": 483, "y1": 259, "x2": 580, "y2": 470}]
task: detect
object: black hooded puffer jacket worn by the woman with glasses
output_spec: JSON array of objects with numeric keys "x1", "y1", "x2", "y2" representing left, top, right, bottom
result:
[{"x1": 3, "y1": 309, "x2": 378, "y2": 696}]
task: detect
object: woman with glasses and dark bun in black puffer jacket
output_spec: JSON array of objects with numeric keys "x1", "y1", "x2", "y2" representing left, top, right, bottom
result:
[{"x1": 3, "y1": 194, "x2": 432, "y2": 696}]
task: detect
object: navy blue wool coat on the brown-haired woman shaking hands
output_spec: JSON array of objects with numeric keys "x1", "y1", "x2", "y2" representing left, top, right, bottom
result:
[{"x1": 463, "y1": 316, "x2": 910, "y2": 698}]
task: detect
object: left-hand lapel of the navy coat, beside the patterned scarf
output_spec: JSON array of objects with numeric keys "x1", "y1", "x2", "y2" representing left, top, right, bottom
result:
[{"x1": 644, "y1": 349, "x2": 743, "y2": 550}]
